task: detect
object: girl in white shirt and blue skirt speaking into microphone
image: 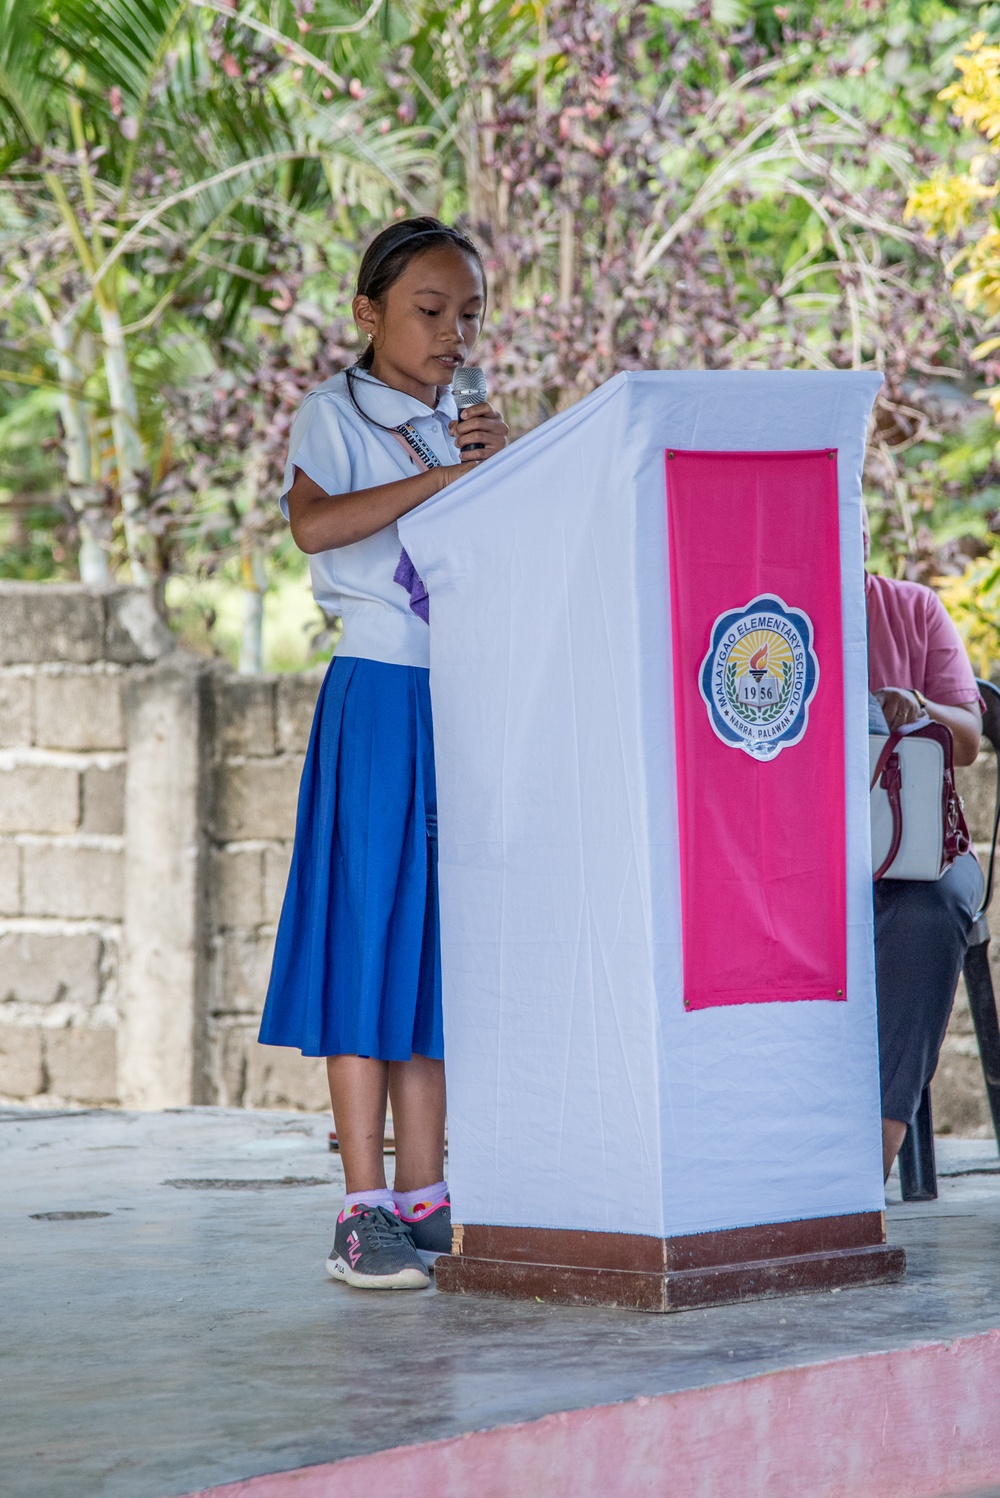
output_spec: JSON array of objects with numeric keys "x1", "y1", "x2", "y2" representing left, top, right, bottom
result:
[{"x1": 260, "y1": 217, "x2": 507, "y2": 1290}]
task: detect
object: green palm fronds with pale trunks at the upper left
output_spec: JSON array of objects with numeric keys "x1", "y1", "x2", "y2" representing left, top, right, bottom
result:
[{"x1": 0, "y1": 0, "x2": 434, "y2": 581}]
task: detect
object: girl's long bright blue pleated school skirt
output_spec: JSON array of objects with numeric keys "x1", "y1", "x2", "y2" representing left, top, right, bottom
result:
[{"x1": 259, "y1": 656, "x2": 445, "y2": 1061}]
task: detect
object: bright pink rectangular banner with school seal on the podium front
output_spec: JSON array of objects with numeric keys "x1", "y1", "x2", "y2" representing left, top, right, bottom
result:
[{"x1": 666, "y1": 449, "x2": 847, "y2": 1010}]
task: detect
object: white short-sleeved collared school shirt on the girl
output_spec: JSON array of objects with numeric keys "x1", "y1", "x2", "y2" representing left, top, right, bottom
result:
[{"x1": 281, "y1": 370, "x2": 458, "y2": 667}]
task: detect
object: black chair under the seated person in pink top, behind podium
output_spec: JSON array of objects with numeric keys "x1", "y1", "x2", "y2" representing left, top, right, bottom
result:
[{"x1": 898, "y1": 682, "x2": 1000, "y2": 1201}]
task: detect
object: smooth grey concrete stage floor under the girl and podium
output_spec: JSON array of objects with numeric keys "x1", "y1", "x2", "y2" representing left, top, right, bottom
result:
[{"x1": 0, "y1": 1109, "x2": 1000, "y2": 1498}]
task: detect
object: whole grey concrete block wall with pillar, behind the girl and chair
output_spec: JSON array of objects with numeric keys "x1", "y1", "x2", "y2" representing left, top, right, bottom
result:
[{"x1": 0, "y1": 583, "x2": 1000, "y2": 1135}]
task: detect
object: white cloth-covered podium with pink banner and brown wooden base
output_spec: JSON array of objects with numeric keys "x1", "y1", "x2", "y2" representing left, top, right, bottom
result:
[{"x1": 400, "y1": 372, "x2": 904, "y2": 1311}]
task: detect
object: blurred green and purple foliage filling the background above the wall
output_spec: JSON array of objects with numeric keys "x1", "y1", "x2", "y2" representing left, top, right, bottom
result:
[{"x1": 0, "y1": 0, "x2": 1000, "y2": 668}]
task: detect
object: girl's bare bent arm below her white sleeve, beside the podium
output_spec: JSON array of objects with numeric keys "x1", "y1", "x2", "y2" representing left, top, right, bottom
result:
[{"x1": 287, "y1": 463, "x2": 470, "y2": 556}]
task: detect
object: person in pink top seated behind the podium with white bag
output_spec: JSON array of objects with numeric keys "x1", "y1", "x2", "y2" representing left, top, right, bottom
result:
[{"x1": 865, "y1": 557, "x2": 984, "y2": 1176}]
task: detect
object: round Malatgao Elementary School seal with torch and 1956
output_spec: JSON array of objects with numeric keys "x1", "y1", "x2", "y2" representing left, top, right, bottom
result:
[{"x1": 699, "y1": 593, "x2": 819, "y2": 759}]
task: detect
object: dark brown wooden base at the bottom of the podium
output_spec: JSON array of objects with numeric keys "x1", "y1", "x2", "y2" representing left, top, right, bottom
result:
[{"x1": 436, "y1": 1212, "x2": 906, "y2": 1311}]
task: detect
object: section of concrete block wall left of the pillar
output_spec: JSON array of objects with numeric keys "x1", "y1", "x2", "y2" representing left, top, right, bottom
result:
[{"x1": 0, "y1": 583, "x2": 172, "y2": 1103}]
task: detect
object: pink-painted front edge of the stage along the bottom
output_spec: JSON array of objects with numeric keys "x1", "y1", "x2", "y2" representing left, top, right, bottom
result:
[{"x1": 189, "y1": 1329, "x2": 1000, "y2": 1498}]
